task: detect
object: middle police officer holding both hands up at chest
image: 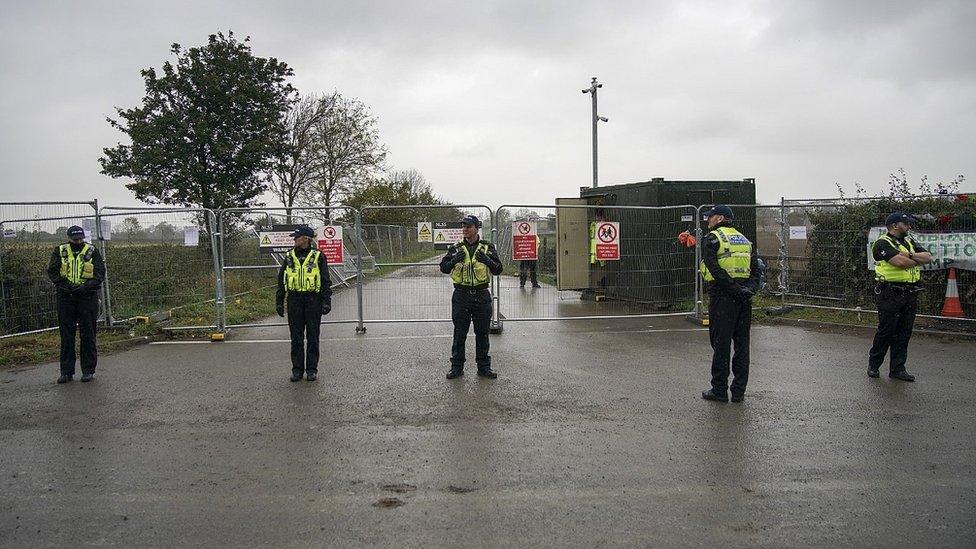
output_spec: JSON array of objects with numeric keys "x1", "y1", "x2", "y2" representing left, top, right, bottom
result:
[{"x1": 441, "y1": 215, "x2": 502, "y2": 379}]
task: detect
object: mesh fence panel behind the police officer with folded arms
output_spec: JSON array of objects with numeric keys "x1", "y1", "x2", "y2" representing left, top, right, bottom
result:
[{"x1": 781, "y1": 195, "x2": 976, "y2": 331}]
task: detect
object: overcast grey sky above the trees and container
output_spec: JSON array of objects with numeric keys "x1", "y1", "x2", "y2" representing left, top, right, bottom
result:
[{"x1": 0, "y1": 0, "x2": 976, "y2": 205}]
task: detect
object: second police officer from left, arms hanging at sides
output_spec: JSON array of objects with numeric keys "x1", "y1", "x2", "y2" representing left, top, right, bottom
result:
[{"x1": 275, "y1": 225, "x2": 332, "y2": 381}]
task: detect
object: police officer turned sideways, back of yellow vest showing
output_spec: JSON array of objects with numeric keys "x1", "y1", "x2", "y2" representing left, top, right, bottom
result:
[{"x1": 699, "y1": 204, "x2": 760, "y2": 402}]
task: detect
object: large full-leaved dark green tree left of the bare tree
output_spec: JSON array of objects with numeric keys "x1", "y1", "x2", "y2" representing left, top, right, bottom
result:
[{"x1": 99, "y1": 32, "x2": 295, "y2": 212}]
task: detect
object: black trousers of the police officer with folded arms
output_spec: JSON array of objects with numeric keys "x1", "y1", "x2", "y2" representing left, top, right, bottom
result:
[{"x1": 868, "y1": 284, "x2": 918, "y2": 373}]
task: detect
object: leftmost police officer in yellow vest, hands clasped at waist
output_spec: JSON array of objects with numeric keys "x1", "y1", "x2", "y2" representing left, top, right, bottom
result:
[{"x1": 47, "y1": 225, "x2": 105, "y2": 383}]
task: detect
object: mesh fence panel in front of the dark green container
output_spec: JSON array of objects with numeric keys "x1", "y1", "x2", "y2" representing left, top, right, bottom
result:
[{"x1": 496, "y1": 204, "x2": 696, "y2": 322}]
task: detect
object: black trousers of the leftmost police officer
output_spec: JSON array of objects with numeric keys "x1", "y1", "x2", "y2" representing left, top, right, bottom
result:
[{"x1": 58, "y1": 290, "x2": 98, "y2": 376}]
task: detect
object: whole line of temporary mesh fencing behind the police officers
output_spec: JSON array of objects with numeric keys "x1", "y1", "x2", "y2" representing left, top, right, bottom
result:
[{"x1": 0, "y1": 195, "x2": 976, "y2": 337}]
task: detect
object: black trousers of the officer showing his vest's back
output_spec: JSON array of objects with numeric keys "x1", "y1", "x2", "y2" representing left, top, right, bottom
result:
[{"x1": 708, "y1": 292, "x2": 752, "y2": 395}]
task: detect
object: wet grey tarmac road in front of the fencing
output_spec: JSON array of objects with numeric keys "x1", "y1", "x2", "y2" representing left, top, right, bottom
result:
[{"x1": 0, "y1": 319, "x2": 976, "y2": 547}]
